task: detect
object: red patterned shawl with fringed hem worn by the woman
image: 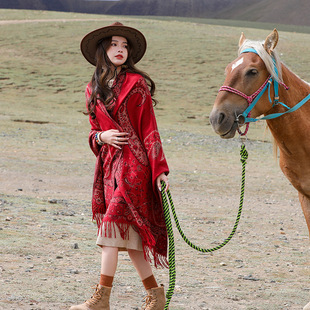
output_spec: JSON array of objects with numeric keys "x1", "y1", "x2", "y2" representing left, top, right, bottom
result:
[{"x1": 86, "y1": 73, "x2": 169, "y2": 267}]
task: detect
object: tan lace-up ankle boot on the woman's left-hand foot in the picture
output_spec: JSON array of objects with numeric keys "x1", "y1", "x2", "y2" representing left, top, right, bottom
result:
[{"x1": 70, "y1": 285, "x2": 112, "y2": 310}]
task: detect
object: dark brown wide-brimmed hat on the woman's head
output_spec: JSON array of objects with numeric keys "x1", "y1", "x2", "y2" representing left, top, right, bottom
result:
[{"x1": 80, "y1": 25, "x2": 146, "y2": 66}]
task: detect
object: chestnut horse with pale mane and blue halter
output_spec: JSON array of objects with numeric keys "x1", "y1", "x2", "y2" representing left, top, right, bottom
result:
[{"x1": 210, "y1": 29, "x2": 310, "y2": 310}]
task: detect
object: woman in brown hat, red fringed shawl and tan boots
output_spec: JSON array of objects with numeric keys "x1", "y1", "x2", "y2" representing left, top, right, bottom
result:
[{"x1": 70, "y1": 23, "x2": 169, "y2": 310}]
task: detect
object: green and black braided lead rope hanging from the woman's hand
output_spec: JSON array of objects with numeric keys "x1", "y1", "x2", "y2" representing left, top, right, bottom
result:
[{"x1": 161, "y1": 144, "x2": 248, "y2": 310}]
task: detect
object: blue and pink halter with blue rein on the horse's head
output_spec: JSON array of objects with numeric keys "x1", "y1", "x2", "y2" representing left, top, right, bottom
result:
[{"x1": 219, "y1": 48, "x2": 310, "y2": 136}]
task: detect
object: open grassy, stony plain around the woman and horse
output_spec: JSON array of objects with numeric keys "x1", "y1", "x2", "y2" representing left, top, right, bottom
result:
[{"x1": 0, "y1": 10, "x2": 310, "y2": 310}]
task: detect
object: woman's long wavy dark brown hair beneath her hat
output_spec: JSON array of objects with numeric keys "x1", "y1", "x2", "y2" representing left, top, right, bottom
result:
[{"x1": 85, "y1": 37, "x2": 157, "y2": 119}]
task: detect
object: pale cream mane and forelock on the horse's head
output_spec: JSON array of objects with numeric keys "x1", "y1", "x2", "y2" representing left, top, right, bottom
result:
[{"x1": 238, "y1": 40, "x2": 282, "y2": 82}]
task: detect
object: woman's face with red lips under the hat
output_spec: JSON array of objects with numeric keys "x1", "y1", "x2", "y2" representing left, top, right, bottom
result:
[{"x1": 107, "y1": 36, "x2": 128, "y2": 67}]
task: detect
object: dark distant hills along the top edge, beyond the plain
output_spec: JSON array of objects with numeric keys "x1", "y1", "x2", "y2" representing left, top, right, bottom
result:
[{"x1": 0, "y1": 0, "x2": 310, "y2": 26}]
